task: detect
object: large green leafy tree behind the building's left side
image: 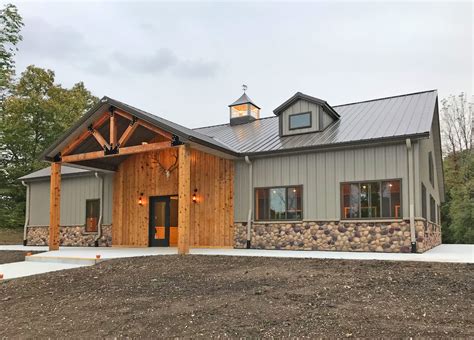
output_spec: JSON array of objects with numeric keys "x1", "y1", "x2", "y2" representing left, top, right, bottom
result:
[{"x1": 0, "y1": 66, "x2": 98, "y2": 227}]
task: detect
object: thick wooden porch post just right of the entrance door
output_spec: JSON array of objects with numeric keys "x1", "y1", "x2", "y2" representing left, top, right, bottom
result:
[{"x1": 178, "y1": 145, "x2": 192, "y2": 255}]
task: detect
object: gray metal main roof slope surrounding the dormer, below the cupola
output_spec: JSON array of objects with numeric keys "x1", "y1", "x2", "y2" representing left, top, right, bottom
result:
[{"x1": 195, "y1": 90, "x2": 437, "y2": 154}]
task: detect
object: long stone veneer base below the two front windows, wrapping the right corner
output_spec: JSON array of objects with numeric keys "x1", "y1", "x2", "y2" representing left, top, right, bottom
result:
[{"x1": 234, "y1": 221, "x2": 441, "y2": 253}]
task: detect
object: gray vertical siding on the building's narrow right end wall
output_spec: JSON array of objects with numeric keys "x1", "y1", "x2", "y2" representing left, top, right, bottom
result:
[{"x1": 415, "y1": 130, "x2": 441, "y2": 222}]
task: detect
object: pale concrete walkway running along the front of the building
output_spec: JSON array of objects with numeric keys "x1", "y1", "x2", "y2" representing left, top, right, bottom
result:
[{"x1": 0, "y1": 244, "x2": 474, "y2": 279}]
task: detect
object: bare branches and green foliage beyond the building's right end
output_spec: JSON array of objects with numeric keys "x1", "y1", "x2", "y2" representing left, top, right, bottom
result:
[{"x1": 441, "y1": 93, "x2": 474, "y2": 243}]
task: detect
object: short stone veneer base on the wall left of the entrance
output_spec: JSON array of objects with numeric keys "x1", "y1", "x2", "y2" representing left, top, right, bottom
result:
[{"x1": 26, "y1": 225, "x2": 112, "y2": 247}]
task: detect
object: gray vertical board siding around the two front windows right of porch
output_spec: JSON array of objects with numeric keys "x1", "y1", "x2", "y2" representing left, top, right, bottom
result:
[{"x1": 234, "y1": 143, "x2": 409, "y2": 222}]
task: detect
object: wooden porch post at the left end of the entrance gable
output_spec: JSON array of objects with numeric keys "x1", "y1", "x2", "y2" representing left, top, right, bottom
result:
[{"x1": 49, "y1": 163, "x2": 61, "y2": 250}]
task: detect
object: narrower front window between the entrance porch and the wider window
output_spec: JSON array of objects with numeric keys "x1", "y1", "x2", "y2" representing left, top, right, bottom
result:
[{"x1": 255, "y1": 186, "x2": 303, "y2": 220}]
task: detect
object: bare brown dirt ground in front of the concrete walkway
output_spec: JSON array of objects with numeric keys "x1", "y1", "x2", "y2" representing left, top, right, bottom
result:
[{"x1": 0, "y1": 256, "x2": 474, "y2": 338}]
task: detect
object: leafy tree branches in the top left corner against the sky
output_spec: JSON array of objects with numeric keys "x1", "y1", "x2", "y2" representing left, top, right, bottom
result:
[{"x1": 0, "y1": 4, "x2": 23, "y2": 99}]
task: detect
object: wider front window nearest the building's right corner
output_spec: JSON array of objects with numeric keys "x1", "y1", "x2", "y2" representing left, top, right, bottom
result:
[{"x1": 341, "y1": 180, "x2": 402, "y2": 219}]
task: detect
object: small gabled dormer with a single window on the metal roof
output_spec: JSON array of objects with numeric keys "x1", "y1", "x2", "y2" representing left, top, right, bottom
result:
[{"x1": 273, "y1": 92, "x2": 340, "y2": 136}]
